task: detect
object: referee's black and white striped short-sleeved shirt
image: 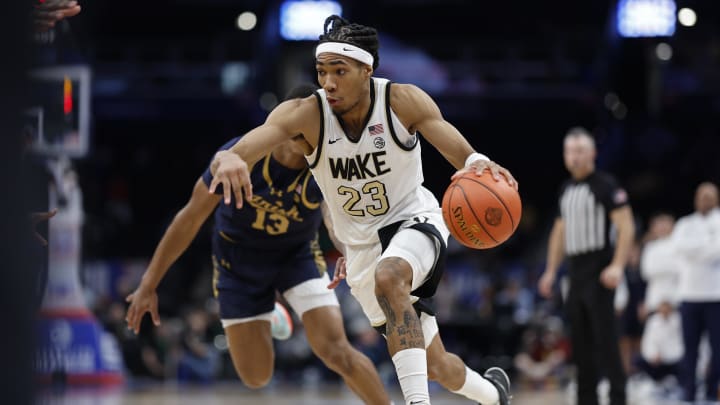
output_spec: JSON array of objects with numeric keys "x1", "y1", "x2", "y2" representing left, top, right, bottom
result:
[{"x1": 558, "y1": 171, "x2": 629, "y2": 257}]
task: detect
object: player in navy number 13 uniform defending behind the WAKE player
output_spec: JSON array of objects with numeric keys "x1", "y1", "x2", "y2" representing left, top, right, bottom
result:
[{"x1": 127, "y1": 86, "x2": 390, "y2": 405}]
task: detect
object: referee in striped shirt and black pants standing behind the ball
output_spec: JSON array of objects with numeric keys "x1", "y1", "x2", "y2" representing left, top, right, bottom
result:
[{"x1": 538, "y1": 127, "x2": 635, "y2": 405}]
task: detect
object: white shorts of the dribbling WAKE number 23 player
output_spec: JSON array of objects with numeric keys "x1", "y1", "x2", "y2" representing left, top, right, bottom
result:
[{"x1": 346, "y1": 210, "x2": 450, "y2": 332}]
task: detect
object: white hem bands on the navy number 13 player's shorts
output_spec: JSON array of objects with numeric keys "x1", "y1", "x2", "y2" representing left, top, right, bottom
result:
[{"x1": 220, "y1": 273, "x2": 340, "y2": 328}]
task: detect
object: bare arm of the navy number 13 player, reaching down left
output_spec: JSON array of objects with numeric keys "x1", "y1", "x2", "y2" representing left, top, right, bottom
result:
[{"x1": 125, "y1": 178, "x2": 220, "y2": 333}]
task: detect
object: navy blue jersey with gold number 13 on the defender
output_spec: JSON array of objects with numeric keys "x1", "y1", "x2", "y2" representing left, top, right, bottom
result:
[{"x1": 203, "y1": 137, "x2": 322, "y2": 249}]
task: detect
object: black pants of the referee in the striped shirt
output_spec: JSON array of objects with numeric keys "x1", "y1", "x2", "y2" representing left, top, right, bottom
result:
[{"x1": 565, "y1": 252, "x2": 626, "y2": 405}]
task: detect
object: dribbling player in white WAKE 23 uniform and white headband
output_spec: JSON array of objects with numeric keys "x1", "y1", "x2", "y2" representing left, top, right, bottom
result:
[{"x1": 210, "y1": 16, "x2": 517, "y2": 405}]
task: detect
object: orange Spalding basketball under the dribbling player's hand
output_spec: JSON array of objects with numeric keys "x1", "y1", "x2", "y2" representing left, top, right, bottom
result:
[{"x1": 442, "y1": 171, "x2": 522, "y2": 249}]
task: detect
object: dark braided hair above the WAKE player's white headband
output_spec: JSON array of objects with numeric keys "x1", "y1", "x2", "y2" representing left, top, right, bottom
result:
[{"x1": 319, "y1": 14, "x2": 380, "y2": 69}]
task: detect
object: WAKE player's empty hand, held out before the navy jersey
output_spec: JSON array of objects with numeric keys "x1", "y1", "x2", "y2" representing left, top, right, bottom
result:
[{"x1": 209, "y1": 151, "x2": 252, "y2": 209}]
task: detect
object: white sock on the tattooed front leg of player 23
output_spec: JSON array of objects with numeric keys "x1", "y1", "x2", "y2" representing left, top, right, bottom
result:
[{"x1": 392, "y1": 349, "x2": 430, "y2": 405}]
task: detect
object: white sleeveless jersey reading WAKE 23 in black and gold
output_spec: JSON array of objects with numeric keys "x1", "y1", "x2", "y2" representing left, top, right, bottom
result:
[{"x1": 306, "y1": 78, "x2": 440, "y2": 246}]
